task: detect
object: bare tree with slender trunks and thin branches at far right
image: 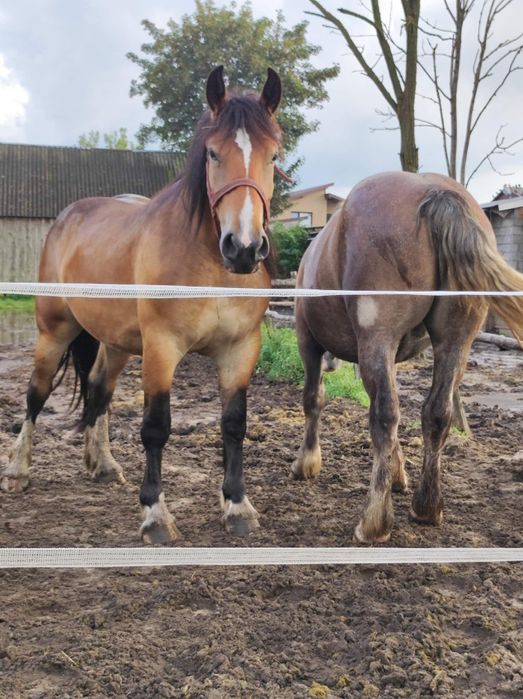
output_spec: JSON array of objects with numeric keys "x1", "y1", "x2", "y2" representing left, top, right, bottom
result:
[{"x1": 417, "y1": 0, "x2": 523, "y2": 186}]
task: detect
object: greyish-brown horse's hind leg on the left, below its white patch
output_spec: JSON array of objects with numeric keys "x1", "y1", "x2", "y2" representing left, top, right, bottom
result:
[{"x1": 354, "y1": 338, "x2": 402, "y2": 543}]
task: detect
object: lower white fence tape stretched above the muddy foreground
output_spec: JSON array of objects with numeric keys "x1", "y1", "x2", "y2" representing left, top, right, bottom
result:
[{"x1": 0, "y1": 547, "x2": 523, "y2": 569}]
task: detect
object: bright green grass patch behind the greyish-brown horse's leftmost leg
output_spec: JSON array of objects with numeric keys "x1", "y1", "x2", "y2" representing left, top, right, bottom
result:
[{"x1": 257, "y1": 326, "x2": 369, "y2": 407}]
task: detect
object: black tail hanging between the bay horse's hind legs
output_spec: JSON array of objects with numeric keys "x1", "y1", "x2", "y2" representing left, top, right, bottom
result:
[{"x1": 53, "y1": 330, "x2": 100, "y2": 432}]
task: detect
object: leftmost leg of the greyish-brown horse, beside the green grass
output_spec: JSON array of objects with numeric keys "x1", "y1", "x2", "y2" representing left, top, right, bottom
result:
[{"x1": 291, "y1": 324, "x2": 325, "y2": 479}]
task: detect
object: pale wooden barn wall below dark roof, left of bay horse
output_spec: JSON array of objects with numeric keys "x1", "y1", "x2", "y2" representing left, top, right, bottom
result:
[{"x1": 0, "y1": 218, "x2": 52, "y2": 282}]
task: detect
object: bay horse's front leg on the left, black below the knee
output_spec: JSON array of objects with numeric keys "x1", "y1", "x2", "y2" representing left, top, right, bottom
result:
[{"x1": 140, "y1": 334, "x2": 182, "y2": 544}]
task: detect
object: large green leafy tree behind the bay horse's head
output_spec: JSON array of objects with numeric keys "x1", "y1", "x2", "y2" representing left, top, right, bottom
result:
[{"x1": 127, "y1": 0, "x2": 339, "y2": 209}]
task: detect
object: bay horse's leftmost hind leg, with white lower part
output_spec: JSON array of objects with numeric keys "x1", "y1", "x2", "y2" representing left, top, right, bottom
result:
[{"x1": 0, "y1": 319, "x2": 80, "y2": 493}]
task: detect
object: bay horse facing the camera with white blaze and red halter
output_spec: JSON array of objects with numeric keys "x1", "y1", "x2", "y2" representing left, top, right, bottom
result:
[{"x1": 2, "y1": 66, "x2": 282, "y2": 543}]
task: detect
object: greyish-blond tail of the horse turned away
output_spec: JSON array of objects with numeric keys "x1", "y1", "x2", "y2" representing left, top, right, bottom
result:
[{"x1": 418, "y1": 190, "x2": 523, "y2": 346}]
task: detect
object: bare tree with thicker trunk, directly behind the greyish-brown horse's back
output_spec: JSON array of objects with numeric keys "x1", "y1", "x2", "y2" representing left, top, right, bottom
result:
[{"x1": 307, "y1": 0, "x2": 420, "y2": 172}]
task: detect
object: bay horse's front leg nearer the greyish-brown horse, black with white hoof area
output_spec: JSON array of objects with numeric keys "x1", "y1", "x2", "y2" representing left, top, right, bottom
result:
[{"x1": 216, "y1": 331, "x2": 260, "y2": 536}]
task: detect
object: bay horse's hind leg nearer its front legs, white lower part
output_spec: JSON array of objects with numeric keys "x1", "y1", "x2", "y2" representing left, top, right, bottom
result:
[{"x1": 83, "y1": 345, "x2": 129, "y2": 483}]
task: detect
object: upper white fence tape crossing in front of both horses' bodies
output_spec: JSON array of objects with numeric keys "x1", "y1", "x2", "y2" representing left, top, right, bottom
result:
[{"x1": 0, "y1": 282, "x2": 523, "y2": 299}]
